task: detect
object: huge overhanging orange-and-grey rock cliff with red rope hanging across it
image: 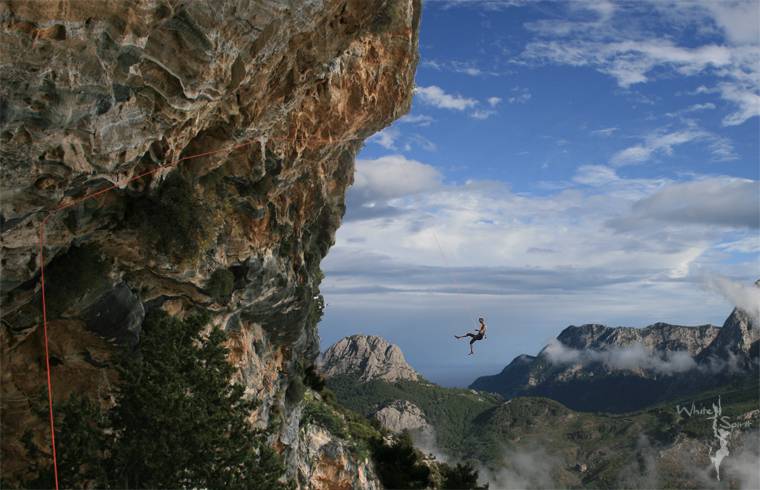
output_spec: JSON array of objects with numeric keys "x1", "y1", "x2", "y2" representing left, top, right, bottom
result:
[{"x1": 0, "y1": 0, "x2": 420, "y2": 487}]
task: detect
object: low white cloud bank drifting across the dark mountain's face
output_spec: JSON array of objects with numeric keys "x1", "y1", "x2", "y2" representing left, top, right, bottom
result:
[{"x1": 542, "y1": 339, "x2": 697, "y2": 375}]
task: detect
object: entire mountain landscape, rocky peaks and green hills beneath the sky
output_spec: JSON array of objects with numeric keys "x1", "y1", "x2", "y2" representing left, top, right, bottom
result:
[{"x1": 320, "y1": 310, "x2": 760, "y2": 489}]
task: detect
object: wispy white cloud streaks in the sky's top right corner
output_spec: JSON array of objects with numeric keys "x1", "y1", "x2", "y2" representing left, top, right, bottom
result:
[{"x1": 521, "y1": 0, "x2": 760, "y2": 126}]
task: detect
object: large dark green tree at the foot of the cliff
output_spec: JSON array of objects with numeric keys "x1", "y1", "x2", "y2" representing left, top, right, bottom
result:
[{"x1": 26, "y1": 313, "x2": 284, "y2": 489}]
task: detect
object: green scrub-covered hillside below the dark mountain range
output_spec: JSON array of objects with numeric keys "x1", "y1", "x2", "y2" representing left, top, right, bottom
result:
[{"x1": 328, "y1": 376, "x2": 758, "y2": 488}]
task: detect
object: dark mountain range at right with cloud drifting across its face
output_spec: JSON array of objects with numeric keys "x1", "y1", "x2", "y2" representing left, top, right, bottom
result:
[{"x1": 470, "y1": 309, "x2": 758, "y2": 412}]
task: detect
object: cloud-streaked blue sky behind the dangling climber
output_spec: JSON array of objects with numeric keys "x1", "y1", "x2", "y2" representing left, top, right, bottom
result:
[{"x1": 320, "y1": 0, "x2": 760, "y2": 385}]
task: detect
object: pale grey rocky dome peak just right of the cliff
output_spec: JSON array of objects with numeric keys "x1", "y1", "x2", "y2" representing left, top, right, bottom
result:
[{"x1": 319, "y1": 335, "x2": 421, "y2": 382}]
